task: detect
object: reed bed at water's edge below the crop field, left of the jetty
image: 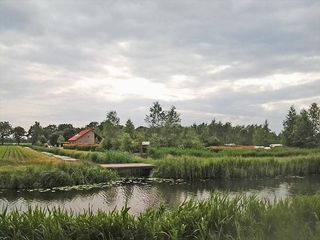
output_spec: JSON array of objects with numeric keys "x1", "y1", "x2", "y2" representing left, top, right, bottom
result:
[{"x1": 0, "y1": 163, "x2": 118, "y2": 189}]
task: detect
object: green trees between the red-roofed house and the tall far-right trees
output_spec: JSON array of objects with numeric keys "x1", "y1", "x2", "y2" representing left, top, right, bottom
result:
[{"x1": 92, "y1": 102, "x2": 280, "y2": 151}]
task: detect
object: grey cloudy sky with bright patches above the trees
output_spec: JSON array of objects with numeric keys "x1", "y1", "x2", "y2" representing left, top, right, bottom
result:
[{"x1": 0, "y1": 0, "x2": 320, "y2": 131}]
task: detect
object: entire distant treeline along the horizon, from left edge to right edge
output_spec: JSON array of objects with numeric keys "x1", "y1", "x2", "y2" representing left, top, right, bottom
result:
[{"x1": 0, "y1": 102, "x2": 320, "y2": 151}]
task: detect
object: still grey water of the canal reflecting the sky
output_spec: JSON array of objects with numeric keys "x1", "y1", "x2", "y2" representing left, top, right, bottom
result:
[{"x1": 0, "y1": 176, "x2": 320, "y2": 215}]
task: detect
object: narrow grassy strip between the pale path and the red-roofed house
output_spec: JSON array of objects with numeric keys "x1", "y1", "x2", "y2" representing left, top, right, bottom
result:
[{"x1": 32, "y1": 146, "x2": 137, "y2": 163}]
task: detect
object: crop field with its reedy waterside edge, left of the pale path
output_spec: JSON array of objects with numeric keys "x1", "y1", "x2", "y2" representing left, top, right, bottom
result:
[{"x1": 0, "y1": 146, "x2": 118, "y2": 189}]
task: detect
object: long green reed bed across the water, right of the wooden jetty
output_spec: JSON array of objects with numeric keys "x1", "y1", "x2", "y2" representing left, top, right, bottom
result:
[{"x1": 152, "y1": 155, "x2": 320, "y2": 180}]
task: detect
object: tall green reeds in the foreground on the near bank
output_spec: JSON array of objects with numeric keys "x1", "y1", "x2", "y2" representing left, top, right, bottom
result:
[{"x1": 0, "y1": 194, "x2": 320, "y2": 240}]
